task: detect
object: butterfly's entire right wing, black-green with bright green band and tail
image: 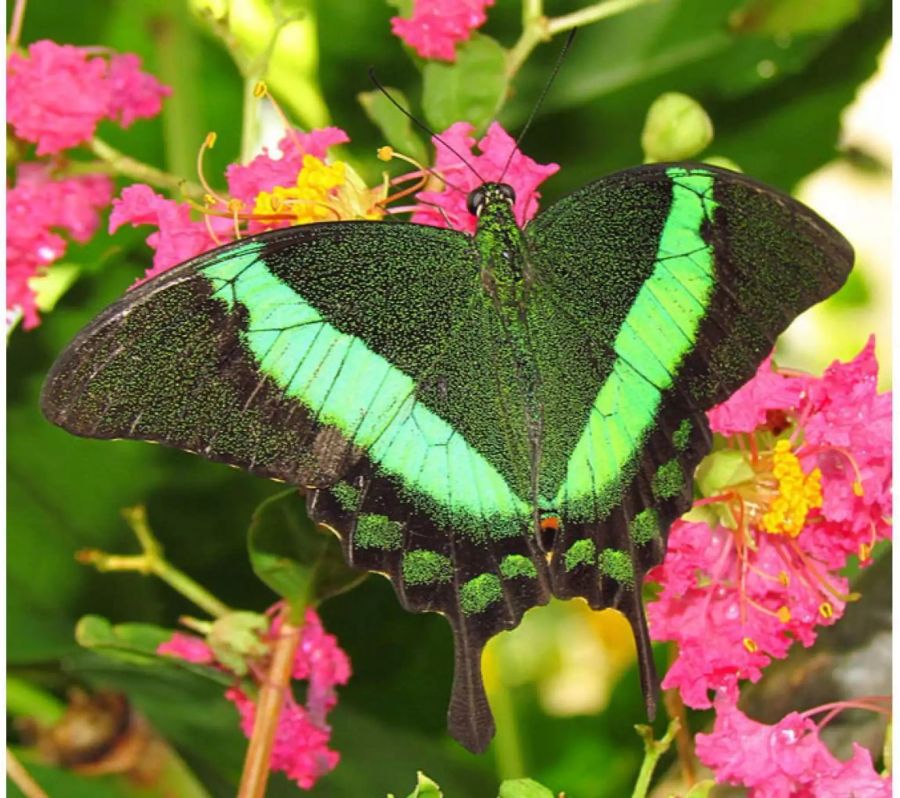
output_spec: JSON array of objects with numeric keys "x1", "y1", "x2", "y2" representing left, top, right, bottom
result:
[{"x1": 525, "y1": 164, "x2": 853, "y2": 707}]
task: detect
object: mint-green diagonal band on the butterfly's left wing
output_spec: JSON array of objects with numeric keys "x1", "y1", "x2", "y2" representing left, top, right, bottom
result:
[{"x1": 202, "y1": 243, "x2": 530, "y2": 535}]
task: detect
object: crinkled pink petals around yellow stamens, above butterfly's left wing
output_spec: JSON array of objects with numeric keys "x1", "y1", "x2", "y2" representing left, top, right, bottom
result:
[{"x1": 109, "y1": 127, "x2": 350, "y2": 283}]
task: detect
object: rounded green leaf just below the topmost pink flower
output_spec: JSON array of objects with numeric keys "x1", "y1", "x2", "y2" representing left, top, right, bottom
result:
[{"x1": 422, "y1": 35, "x2": 509, "y2": 132}]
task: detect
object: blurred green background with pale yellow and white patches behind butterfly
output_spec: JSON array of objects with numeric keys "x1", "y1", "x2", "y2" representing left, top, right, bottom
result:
[{"x1": 7, "y1": 0, "x2": 890, "y2": 798}]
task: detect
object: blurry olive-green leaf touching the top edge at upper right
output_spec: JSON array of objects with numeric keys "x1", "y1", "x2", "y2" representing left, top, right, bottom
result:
[{"x1": 730, "y1": 0, "x2": 862, "y2": 36}]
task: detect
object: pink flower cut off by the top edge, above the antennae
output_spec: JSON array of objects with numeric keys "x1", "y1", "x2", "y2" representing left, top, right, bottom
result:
[{"x1": 391, "y1": 0, "x2": 494, "y2": 61}]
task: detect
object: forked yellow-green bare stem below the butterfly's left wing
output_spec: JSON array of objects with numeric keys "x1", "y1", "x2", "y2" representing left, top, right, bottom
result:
[{"x1": 75, "y1": 505, "x2": 231, "y2": 618}]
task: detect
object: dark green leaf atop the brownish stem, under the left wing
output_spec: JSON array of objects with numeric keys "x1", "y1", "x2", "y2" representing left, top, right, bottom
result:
[{"x1": 247, "y1": 490, "x2": 366, "y2": 621}]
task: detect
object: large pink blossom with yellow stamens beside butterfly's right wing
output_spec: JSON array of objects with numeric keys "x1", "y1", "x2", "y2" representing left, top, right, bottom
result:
[{"x1": 648, "y1": 340, "x2": 891, "y2": 708}]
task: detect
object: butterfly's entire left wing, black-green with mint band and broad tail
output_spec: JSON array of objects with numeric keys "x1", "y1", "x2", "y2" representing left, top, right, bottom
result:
[{"x1": 42, "y1": 222, "x2": 549, "y2": 750}]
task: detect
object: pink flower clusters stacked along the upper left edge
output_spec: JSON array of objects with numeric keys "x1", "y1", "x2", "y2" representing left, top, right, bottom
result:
[{"x1": 6, "y1": 41, "x2": 169, "y2": 329}]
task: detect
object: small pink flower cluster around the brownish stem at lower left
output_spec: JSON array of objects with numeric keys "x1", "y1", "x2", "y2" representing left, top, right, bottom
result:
[{"x1": 157, "y1": 609, "x2": 350, "y2": 790}]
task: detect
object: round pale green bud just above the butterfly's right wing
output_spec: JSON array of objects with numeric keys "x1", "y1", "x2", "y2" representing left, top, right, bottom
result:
[{"x1": 641, "y1": 92, "x2": 713, "y2": 163}]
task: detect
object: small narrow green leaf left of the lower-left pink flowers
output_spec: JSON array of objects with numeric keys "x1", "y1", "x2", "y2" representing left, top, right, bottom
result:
[{"x1": 75, "y1": 615, "x2": 234, "y2": 685}]
